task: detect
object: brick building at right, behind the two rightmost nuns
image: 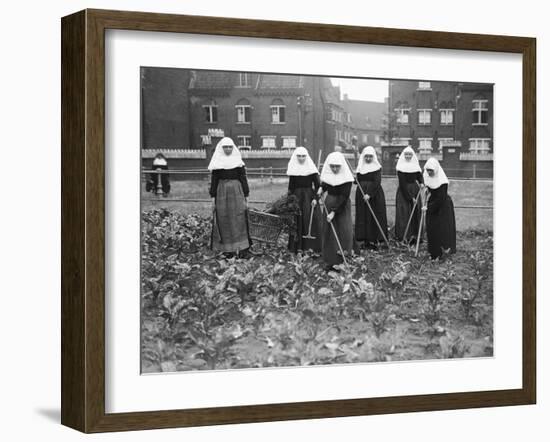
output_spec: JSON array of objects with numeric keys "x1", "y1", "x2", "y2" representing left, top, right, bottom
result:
[{"x1": 382, "y1": 80, "x2": 493, "y2": 177}]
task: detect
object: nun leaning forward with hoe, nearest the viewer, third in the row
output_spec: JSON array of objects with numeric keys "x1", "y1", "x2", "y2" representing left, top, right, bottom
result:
[{"x1": 318, "y1": 152, "x2": 353, "y2": 270}]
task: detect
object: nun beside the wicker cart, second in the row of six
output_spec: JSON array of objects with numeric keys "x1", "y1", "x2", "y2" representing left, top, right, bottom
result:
[{"x1": 286, "y1": 147, "x2": 321, "y2": 253}]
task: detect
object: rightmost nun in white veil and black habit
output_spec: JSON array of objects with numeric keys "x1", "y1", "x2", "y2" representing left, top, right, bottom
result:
[{"x1": 422, "y1": 158, "x2": 456, "y2": 259}]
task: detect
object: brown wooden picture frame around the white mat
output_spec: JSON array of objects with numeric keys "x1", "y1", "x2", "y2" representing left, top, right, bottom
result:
[{"x1": 61, "y1": 10, "x2": 536, "y2": 433}]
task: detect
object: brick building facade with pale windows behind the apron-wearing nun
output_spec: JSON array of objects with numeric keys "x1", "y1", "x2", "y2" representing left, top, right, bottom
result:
[{"x1": 189, "y1": 71, "x2": 306, "y2": 154}]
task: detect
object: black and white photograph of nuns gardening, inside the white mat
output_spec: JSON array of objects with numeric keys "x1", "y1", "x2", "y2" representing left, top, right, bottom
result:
[{"x1": 141, "y1": 66, "x2": 496, "y2": 374}]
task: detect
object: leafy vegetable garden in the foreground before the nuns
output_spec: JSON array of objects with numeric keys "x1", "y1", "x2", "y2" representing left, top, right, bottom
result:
[{"x1": 141, "y1": 209, "x2": 493, "y2": 373}]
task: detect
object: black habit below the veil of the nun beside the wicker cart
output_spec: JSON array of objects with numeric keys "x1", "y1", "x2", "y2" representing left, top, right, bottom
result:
[{"x1": 288, "y1": 187, "x2": 322, "y2": 253}]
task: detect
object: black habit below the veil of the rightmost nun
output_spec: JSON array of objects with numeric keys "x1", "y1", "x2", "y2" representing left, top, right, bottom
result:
[{"x1": 426, "y1": 195, "x2": 456, "y2": 259}]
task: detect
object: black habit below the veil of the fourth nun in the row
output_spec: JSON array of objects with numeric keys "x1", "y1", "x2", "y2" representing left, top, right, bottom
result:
[{"x1": 355, "y1": 187, "x2": 388, "y2": 244}]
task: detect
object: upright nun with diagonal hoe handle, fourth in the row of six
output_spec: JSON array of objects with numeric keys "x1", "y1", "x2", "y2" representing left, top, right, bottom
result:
[{"x1": 355, "y1": 146, "x2": 388, "y2": 249}]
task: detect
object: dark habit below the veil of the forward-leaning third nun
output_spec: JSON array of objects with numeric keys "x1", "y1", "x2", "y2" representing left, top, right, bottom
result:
[{"x1": 323, "y1": 195, "x2": 353, "y2": 266}]
